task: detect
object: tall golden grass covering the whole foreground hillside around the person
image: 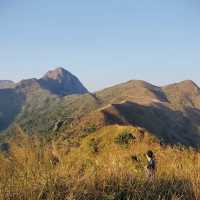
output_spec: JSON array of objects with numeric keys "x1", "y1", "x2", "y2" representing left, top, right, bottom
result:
[{"x1": 0, "y1": 126, "x2": 200, "y2": 200}]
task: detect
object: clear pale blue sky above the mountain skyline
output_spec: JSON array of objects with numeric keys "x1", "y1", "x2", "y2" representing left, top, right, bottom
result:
[{"x1": 0, "y1": 0, "x2": 200, "y2": 91}]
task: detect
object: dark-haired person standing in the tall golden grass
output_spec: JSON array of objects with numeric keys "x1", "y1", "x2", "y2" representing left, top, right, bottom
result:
[{"x1": 146, "y1": 151, "x2": 156, "y2": 180}]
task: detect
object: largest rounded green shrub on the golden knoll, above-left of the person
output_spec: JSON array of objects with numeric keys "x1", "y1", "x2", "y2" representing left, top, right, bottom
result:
[{"x1": 115, "y1": 131, "x2": 136, "y2": 145}]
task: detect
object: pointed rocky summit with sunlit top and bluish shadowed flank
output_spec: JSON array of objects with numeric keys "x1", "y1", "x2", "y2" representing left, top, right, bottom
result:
[{"x1": 39, "y1": 68, "x2": 88, "y2": 96}]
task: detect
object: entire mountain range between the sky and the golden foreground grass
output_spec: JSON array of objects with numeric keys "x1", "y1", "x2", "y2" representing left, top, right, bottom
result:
[{"x1": 0, "y1": 68, "x2": 200, "y2": 147}]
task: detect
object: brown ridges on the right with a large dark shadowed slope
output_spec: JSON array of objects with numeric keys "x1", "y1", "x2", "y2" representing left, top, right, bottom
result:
[{"x1": 66, "y1": 81, "x2": 200, "y2": 147}]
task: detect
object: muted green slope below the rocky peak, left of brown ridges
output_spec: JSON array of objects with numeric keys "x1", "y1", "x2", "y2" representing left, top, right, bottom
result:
[{"x1": 16, "y1": 91, "x2": 97, "y2": 134}]
